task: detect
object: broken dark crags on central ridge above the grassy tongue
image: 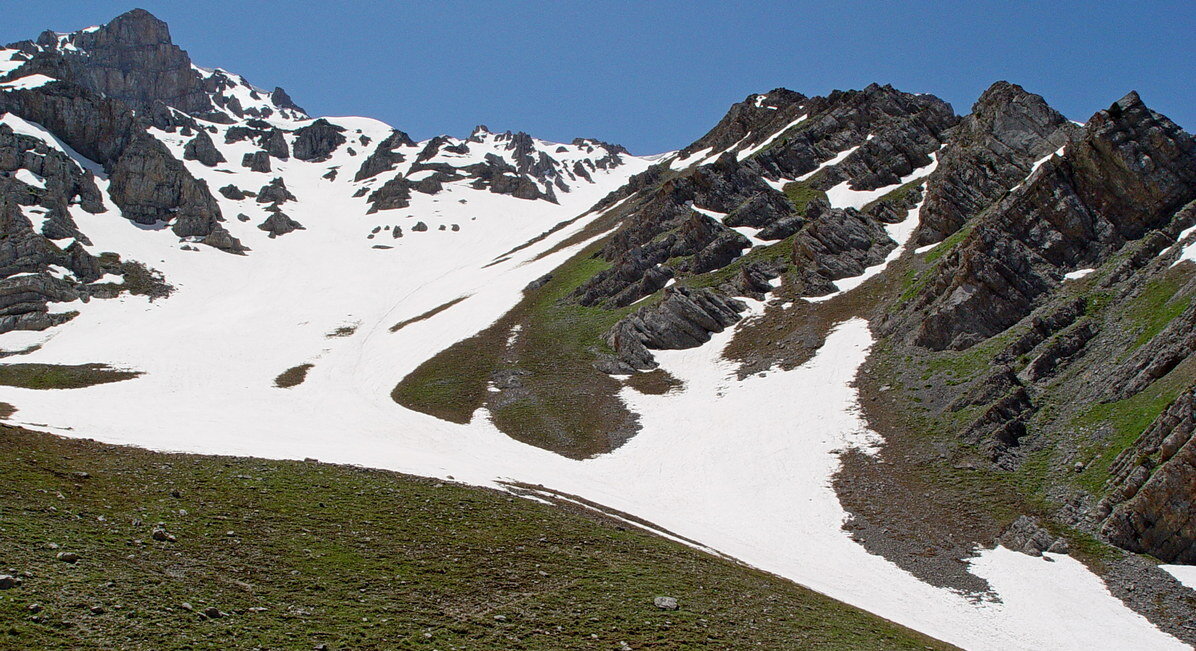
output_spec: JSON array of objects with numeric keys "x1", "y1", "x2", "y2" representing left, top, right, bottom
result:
[{"x1": 575, "y1": 85, "x2": 956, "y2": 318}]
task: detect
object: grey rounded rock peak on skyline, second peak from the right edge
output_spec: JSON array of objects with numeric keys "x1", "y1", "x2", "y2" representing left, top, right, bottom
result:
[{"x1": 915, "y1": 81, "x2": 1081, "y2": 245}]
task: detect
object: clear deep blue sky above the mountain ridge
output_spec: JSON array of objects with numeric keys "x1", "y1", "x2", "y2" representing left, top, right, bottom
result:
[{"x1": 0, "y1": 0, "x2": 1196, "y2": 153}]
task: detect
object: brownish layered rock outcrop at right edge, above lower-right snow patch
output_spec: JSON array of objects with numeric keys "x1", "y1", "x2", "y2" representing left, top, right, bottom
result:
[{"x1": 1097, "y1": 390, "x2": 1196, "y2": 565}]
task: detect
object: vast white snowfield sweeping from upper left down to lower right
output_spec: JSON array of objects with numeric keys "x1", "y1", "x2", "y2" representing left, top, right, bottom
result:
[{"x1": 0, "y1": 99, "x2": 1184, "y2": 650}]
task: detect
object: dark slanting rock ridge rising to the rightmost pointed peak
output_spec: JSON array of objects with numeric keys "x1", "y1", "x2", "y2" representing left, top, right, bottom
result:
[{"x1": 913, "y1": 93, "x2": 1196, "y2": 349}]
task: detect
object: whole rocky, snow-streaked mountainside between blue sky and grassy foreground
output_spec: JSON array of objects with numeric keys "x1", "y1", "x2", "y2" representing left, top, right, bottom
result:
[{"x1": 0, "y1": 10, "x2": 1196, "y2": 649}]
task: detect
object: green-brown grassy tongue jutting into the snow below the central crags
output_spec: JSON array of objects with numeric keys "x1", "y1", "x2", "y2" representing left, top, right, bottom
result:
[{"x1": 391, "y1": 241, "x2": 655, "y2": 458}]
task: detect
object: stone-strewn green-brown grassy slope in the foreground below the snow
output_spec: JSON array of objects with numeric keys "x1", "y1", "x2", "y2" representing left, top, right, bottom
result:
[{"x1": 0, "y1": 426, "x2": 942, "y2": 650}]
